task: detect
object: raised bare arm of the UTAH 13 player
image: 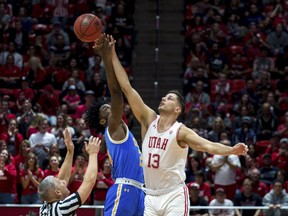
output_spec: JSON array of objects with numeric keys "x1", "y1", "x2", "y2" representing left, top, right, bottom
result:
[{"x1": 112, "y1": 39, "x2": 156, "y2": 134}]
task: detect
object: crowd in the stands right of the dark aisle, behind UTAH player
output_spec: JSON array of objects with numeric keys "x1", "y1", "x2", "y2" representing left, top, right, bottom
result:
[{"x1": 183, "y1": 0, "x2": 288, "y2": 216}]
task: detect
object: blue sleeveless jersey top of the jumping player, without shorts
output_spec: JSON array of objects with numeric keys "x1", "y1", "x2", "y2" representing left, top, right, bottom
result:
[{"x1": 105, "y1": 124, "x2": 144, "y2": 183}]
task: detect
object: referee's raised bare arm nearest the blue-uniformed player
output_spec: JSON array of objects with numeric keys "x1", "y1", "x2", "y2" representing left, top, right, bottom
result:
[{"x1": 77, "y1": 136, "x2": 101, "y2": 204}]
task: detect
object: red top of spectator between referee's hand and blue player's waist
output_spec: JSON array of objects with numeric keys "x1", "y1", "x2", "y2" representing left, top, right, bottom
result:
[{"x1": 94, "y1": 173, "x2": 114, "y2": 201}]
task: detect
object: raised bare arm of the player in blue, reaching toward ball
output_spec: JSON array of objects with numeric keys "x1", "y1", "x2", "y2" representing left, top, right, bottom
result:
[{"x1": 94, "y1": 34, "x2": 125, "y2": 140}]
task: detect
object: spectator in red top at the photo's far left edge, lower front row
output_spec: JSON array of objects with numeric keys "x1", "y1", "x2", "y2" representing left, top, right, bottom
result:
[{"x1": 0, "y1": 149, "x2": 16, "y2": 204}]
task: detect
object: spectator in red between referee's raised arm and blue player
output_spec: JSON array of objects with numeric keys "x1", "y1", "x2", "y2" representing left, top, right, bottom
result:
[{"x1": 93, "y1": 158, "x2": 114, "y2": 212}]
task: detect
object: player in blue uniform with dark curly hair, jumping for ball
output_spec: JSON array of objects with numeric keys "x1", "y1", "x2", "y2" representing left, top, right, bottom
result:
[{"x1": 85, "y1": 34, "x2": 145, "y2": 216}]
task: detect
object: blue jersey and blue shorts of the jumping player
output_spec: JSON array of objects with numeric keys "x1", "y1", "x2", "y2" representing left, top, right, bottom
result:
[{"x1": 104, "y1": 124, "x2": 145, "y2": 216}]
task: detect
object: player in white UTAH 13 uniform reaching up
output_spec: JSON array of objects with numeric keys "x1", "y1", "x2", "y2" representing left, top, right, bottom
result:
[{"x1": 105, "y1": 36, "x2": 248, "y2": 216}]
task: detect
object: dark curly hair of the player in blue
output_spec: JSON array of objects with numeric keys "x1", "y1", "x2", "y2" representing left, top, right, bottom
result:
[{"x1": 84, "y1": 97, "x2": 109, "y2": 132}]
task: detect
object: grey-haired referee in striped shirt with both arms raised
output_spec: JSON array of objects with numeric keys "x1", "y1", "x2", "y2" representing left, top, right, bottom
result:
[{"x1": 38, "y1": 128, "x2": 101, "y2": 216}]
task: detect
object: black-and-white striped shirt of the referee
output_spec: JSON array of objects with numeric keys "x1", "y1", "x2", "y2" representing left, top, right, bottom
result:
[{"x1": 40, "y1": 192, "x2": 81, "y2": 216}]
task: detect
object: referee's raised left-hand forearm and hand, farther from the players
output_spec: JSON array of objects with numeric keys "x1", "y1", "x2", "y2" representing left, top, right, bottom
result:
[{"x1": 58, "y1": 128, "x2": 74, "y2": 185}]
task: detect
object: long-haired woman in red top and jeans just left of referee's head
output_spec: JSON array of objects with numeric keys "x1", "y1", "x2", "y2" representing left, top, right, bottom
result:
[{"x1": 20, "y1": 153, "x2": 44, "y2": 204}]
